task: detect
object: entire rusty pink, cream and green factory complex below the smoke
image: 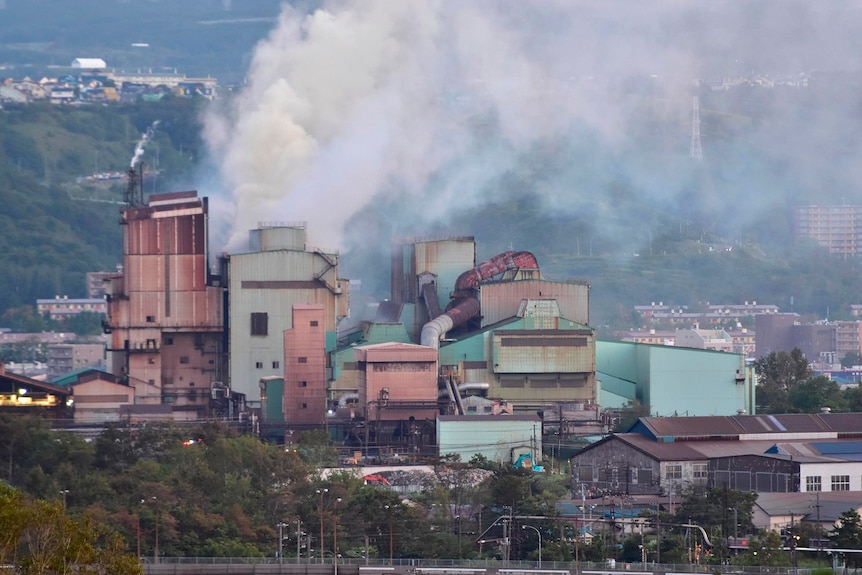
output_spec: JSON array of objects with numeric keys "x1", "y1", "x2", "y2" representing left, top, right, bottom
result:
[{"x1": 0, "y1": 169, "x2": 755, "y2": 465}]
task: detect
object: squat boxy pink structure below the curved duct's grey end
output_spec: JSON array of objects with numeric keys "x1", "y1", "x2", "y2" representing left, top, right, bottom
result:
[{"x1": 356, "y1": 343, "x2": 438, "y2": 421}]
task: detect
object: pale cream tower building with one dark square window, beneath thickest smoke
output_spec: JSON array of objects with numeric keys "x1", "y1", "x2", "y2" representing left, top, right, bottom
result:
[{"x1": 224, "y1": 223, "x2": 350, "y2": 410}]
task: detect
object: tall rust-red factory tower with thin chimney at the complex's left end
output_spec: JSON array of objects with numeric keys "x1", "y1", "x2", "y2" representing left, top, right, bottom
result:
[{"x1": 104, "y1": 170, "x2": 225, "y2": 419}]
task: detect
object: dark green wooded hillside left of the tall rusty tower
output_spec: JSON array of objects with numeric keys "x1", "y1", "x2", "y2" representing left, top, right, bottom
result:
[{"x1": 0, "y1": 99, "x2": 200, "y2": 325}]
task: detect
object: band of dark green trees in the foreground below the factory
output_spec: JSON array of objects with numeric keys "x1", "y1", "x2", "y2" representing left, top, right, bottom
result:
[{"x1": 0, "y1": 415, "x2": 862, "y2": 573}]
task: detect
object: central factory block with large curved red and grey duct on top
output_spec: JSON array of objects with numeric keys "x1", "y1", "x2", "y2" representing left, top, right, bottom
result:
[{"x1": 314, "y1": 237, "x2": 598, "y2": 457}]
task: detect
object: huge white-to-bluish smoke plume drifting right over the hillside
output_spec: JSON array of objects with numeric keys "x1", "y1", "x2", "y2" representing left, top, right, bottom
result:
[{"x1": 206, "y1": 0, "x2": 862, "y2": 258}]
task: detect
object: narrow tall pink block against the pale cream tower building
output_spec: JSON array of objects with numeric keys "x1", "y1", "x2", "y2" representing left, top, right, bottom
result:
[{"x1": 283, "y1": 304, "x2": 328, "y2": 426}]
